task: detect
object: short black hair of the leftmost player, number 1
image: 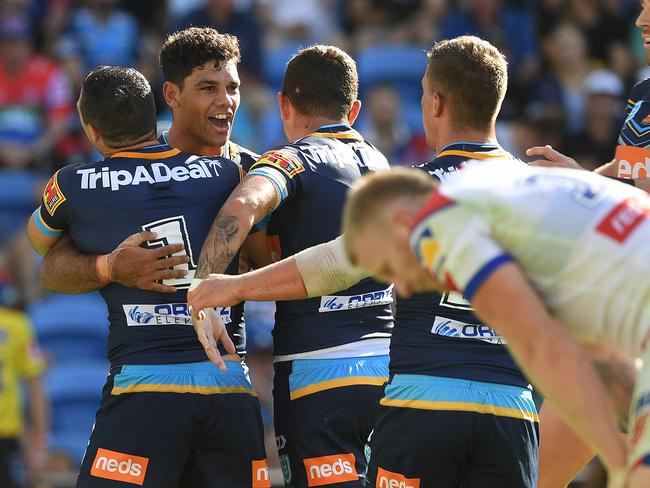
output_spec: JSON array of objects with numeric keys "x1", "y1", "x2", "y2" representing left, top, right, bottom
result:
[{"x1": 79, "y1": 66, "x2": 156, "y2": 148}]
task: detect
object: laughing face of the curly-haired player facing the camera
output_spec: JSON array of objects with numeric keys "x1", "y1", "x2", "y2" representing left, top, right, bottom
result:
[{"x1": 174, "y1": 60, "x2": 240, "y2": 155}]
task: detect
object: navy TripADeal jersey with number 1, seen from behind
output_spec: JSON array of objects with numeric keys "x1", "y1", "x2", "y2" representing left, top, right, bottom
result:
[{"x1": 34, "y1": 144, "x2": 245, "y2": 366}]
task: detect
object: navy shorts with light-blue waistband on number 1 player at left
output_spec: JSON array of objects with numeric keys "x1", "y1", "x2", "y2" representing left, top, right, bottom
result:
[{"x1": 77, "y1": 362, "x2": 271, "y2": 488}]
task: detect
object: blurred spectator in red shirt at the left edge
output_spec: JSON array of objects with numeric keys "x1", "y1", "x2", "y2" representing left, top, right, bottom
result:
[{"x1": 0, "y1": 16, "x2": 73, "y2": 169}]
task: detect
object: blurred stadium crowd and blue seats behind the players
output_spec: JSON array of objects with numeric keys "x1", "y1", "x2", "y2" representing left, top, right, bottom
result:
[{"x1": 0, "y1": 0, "x2": 650, "y2": 486}]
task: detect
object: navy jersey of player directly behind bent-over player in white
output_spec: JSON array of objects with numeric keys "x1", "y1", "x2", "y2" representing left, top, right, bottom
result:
[{"x1": 390, "y1": 143, "x2": 528, "y2": 386}]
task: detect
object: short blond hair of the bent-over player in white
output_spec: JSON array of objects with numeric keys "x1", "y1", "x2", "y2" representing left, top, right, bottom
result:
[{"x1": 342, "y1": 168, "x2": 438, "y2": 264}]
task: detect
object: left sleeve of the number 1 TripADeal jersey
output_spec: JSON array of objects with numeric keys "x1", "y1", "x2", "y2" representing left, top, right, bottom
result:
[{"x1": 34, "y1": 170, "x2": 71, "y2": 237}]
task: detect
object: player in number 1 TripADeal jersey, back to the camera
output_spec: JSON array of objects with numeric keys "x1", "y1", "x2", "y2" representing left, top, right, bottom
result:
[{"x1": 29, "y1": 66, "x2": 270, "y2": 488}]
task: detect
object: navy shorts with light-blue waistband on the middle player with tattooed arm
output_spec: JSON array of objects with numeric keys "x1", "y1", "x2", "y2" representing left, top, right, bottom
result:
[{"x1": 273, "y1": 356, "x2": 388, "y2": 488}]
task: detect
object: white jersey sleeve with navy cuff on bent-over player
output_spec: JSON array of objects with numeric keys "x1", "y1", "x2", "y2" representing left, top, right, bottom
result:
[{"x1": 411, "y1": 193, "x2": 512, "y2": 301}]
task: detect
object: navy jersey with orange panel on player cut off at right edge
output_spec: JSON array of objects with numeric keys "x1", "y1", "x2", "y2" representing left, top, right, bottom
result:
[{"x1": 614, "y1": 79, "x2": 650, "y2": 178}]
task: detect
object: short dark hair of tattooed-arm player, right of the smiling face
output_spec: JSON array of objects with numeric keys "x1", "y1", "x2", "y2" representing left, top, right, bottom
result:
[{"x1": 282, "y1": 44, "x2": 359, "y2": 119}]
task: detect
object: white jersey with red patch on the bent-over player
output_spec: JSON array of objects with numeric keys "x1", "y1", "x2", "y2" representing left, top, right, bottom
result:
[{"x1": 411, "y1": 160, "x2": 650, "y2": 355}]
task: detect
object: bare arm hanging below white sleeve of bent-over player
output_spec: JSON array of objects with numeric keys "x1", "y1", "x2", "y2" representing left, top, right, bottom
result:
[{"x1": 472, "y1": 263, "x2": 625, "y2": 480}]
